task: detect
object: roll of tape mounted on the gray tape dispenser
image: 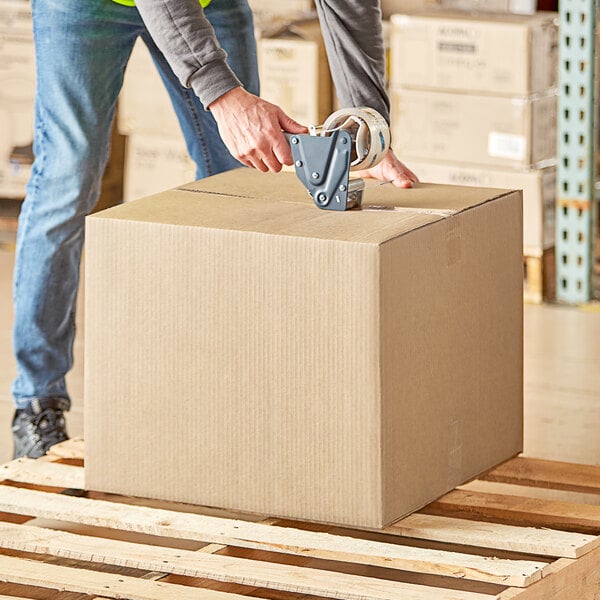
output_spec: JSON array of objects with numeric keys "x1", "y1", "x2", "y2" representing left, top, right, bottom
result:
[{"x1": 321, "y1": 106, "x2": 390, "y2": 171}]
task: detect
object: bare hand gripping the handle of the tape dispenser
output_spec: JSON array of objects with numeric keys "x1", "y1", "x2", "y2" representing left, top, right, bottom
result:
[{"x1": 208, "y1": 87, "x2": 308, "y2": 173}]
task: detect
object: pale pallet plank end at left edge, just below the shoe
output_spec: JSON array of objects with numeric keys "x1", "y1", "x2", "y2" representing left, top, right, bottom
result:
[{"x1": 0, "y1": 458, "x2": 84, "y2": 489}]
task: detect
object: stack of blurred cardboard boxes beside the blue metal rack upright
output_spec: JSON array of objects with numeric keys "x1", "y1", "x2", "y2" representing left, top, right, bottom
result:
[{"x1": 391, "y1": 11, "x2": 558, "y2": 274}]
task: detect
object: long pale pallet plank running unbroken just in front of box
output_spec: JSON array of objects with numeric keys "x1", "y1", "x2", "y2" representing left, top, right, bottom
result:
[{"x1": 0, "y1": 486, "x2": 547, "y2": 586}]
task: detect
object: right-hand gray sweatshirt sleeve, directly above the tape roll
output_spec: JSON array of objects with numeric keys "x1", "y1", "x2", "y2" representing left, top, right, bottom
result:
[{"x1": 315, "y1": 0, "x2": 390, "y2": 123}]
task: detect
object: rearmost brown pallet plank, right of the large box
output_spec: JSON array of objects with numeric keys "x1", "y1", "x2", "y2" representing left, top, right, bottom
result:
[{"x1": 481, "y1": 457, "x2": 600, "y2": 494}]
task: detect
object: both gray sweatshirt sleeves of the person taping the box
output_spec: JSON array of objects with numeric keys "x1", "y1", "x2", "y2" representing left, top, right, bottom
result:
[{"x1": 136, "y1": 0, "x2": 389, "y2": 122}]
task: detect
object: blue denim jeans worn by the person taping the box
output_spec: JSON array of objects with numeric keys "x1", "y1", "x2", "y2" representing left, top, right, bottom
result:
[{"x1": 12, "y1": 0, "x2": 258, "y2": 408}]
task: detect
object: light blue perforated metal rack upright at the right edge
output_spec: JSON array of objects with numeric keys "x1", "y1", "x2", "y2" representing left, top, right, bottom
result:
[{"x1": 556, "y1": 0, "x2": 598, "y2": 304}]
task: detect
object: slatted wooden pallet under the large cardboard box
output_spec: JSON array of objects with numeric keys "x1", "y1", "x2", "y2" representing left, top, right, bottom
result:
[{"x1": 0, "y1": 440, "x2": 600, "y2": 600}]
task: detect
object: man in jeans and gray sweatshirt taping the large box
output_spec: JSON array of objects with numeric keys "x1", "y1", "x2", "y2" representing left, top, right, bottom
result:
[{"x1": 12, "y1": 0, "x2": 416, "y2": 457}]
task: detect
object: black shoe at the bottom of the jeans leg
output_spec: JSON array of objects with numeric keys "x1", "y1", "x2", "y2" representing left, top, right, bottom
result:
[{"x1": 12, "y1": 398, "x2": 69, "y2": 458}]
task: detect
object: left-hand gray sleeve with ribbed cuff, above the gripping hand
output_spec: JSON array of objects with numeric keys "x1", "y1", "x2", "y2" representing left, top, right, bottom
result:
[{"x1": 136, "y1": 0, "x2": 242, "y2": 107}]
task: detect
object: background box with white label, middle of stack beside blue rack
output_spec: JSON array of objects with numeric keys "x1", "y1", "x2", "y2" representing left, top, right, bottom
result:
[{"x1": 392, "y1": 89, "x2": 557, "y2": 169}]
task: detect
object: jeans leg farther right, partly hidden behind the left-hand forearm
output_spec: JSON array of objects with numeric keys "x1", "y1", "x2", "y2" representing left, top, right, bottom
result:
[{"x1": 142, "y1": 0, "x2": 259, "y2": 179}]
